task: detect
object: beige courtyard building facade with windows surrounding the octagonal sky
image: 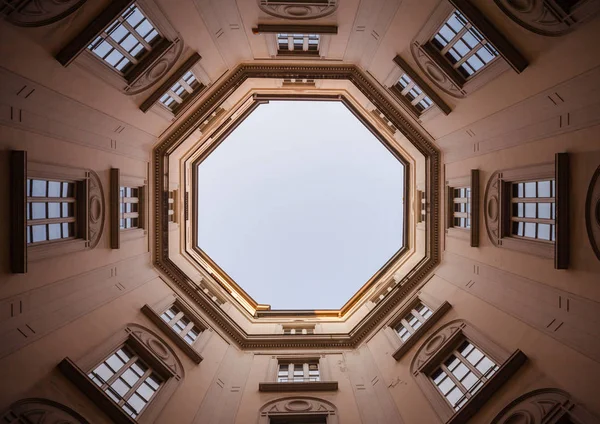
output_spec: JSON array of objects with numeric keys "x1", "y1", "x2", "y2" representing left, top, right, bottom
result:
[{"x1": 0, "y1": 0, "x2": 600, "y2": 424}]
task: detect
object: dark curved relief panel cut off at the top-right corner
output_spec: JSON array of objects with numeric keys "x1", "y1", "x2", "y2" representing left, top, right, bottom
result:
[{"x1": 494, "y1": 0, "x2": 600, "y2": 36}]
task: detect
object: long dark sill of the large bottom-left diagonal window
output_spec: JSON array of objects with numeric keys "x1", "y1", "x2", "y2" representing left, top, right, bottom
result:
[{"x1": 58, "y1": 358, "x2": 137, "y2": 424}]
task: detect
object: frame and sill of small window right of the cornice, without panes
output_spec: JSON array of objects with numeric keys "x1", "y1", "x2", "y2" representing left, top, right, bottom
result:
[{"x1": 446, "y1": 169, "x2": 480, "y2": 247}]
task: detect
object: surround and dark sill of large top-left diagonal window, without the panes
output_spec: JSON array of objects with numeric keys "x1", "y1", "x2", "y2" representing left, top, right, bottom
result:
[{"x1": 56, "y1": 0, "x2": 183, "y2": 95}]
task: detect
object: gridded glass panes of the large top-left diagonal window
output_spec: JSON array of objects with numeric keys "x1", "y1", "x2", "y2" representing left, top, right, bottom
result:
[{"x1": 88, "y1": 3, "x2": 162, "y2": 75}]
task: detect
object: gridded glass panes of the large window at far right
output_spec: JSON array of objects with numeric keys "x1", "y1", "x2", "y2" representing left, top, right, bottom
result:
[{"x1": 510, "y1": 179, "x2": 556, "y2": 242}]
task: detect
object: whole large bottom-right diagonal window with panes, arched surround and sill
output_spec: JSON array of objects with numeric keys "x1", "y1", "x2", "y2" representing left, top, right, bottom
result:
[{"x1": 411, "y1": 320, "x2": 527, "y2": 424}]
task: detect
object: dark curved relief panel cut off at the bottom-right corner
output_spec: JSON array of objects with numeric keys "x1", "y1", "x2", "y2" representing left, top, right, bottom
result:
[{"x1": 491, "y1": 389, "x2": 598, "y2": 424}]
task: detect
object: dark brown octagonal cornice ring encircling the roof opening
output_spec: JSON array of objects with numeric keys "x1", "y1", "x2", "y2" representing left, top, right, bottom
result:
[{"x1": 153, "y1": 64, "x2": 440, "y2": 349}]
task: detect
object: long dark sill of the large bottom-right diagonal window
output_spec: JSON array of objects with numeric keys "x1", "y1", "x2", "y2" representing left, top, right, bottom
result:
[{"x1": 446, "y1": 349, "x2": 527, "y2": 424}]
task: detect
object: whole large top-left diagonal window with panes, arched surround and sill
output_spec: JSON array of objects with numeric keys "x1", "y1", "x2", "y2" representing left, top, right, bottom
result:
[{"x1": 56, "y1": 0, "x2": 183, "y2": 95}]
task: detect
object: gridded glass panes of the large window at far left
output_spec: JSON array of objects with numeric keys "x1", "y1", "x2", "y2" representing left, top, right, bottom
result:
[{"x1": 26, "y1": 178, "x2": 77, "y2": 245}]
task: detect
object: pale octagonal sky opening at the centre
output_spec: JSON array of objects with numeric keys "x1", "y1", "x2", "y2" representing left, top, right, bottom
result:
[{"x1": 196, "y1": 101, "x2": 405, "y2": 310}]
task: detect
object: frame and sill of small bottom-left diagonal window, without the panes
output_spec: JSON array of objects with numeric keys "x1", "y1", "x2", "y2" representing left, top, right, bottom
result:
[{"x1": 141, "y1": 295, "x2": 213, "y2": 364}]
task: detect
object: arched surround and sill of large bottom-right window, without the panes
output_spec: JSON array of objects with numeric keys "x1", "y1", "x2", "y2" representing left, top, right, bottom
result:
[{"x1": 411, "y1": 320, "x2": 527, "y2": 424}]
